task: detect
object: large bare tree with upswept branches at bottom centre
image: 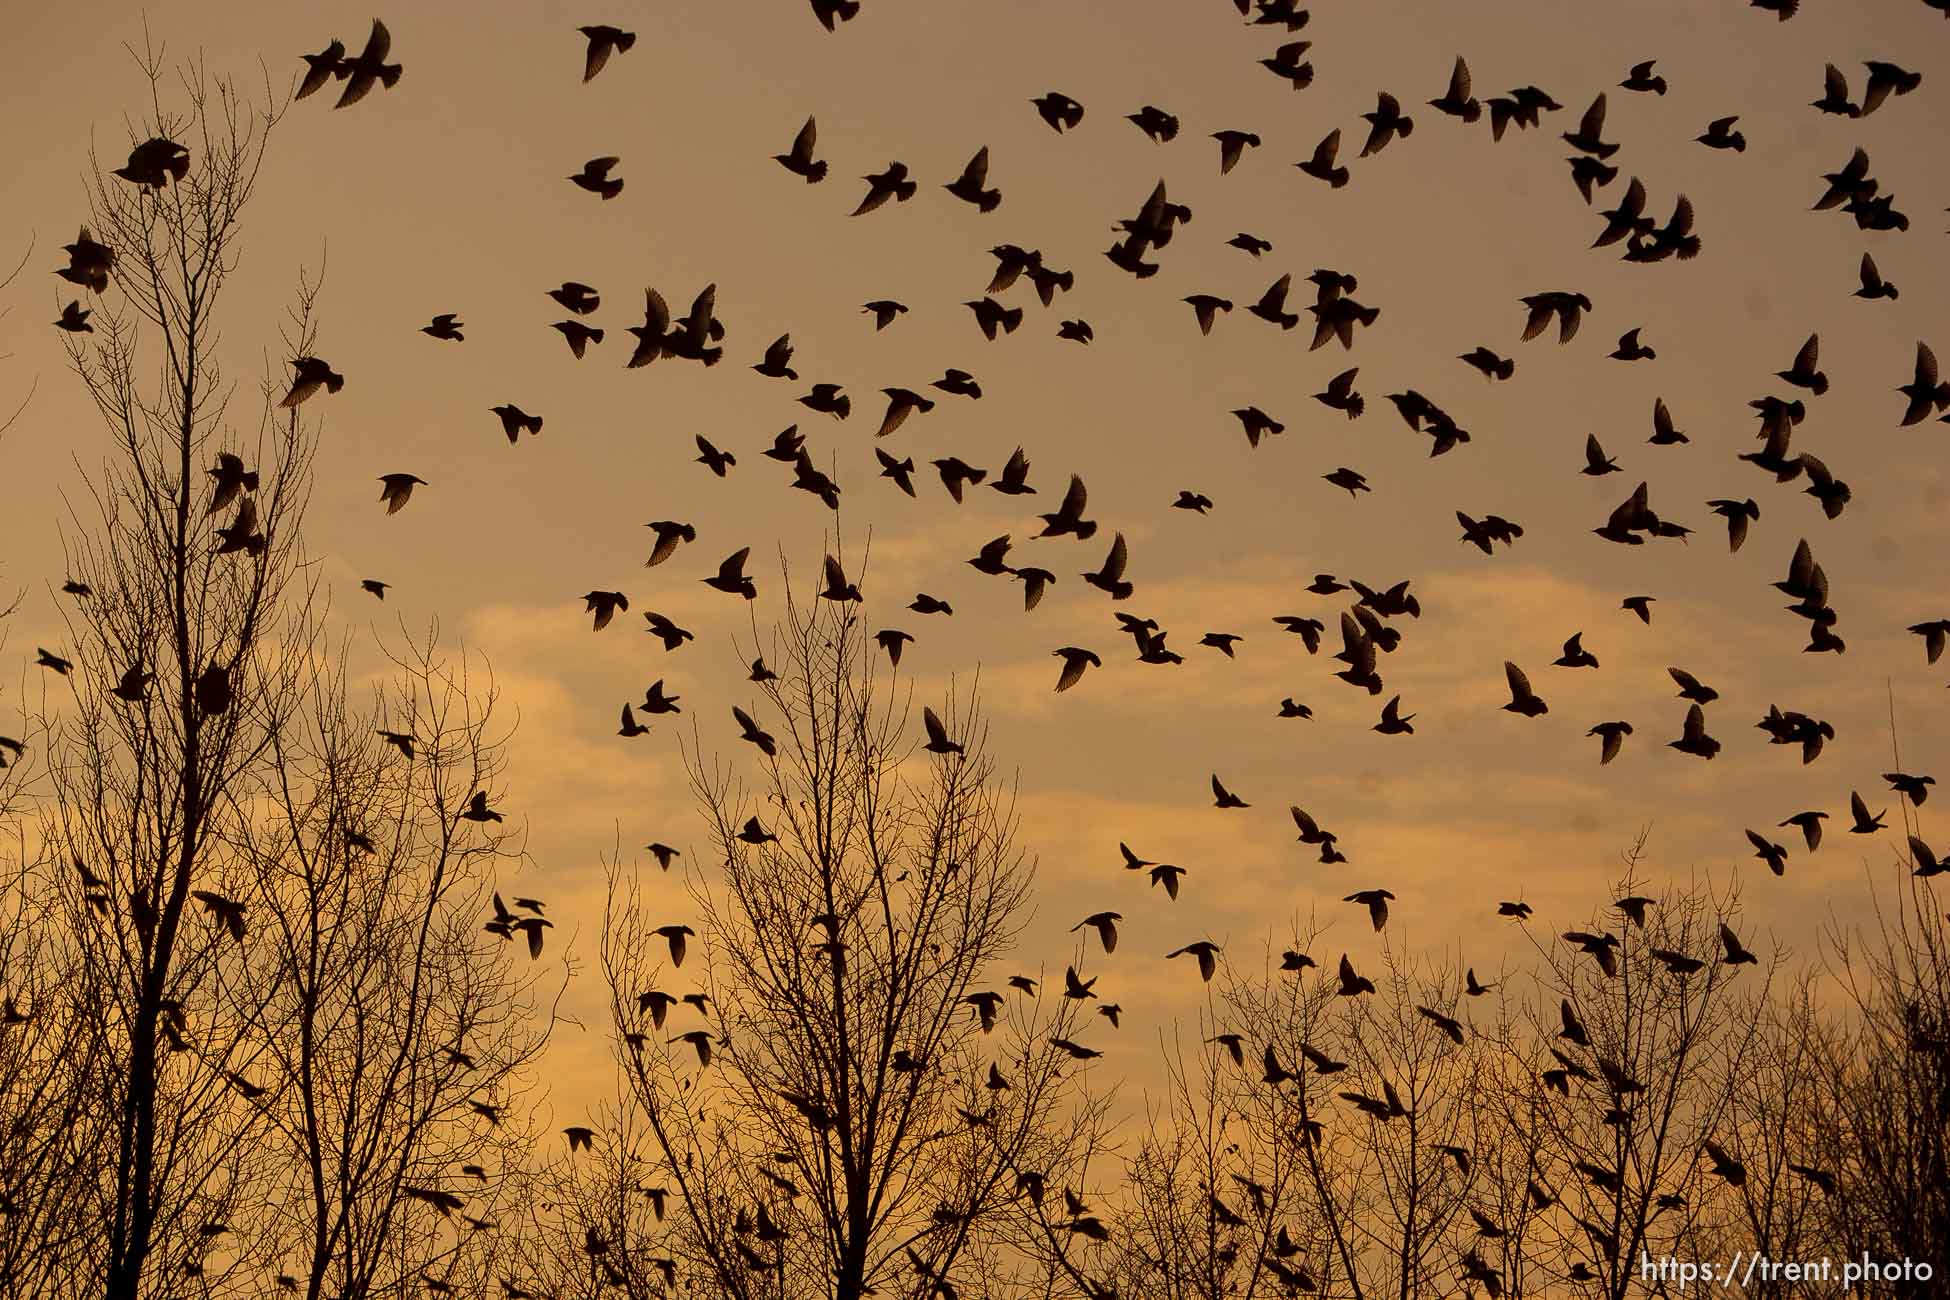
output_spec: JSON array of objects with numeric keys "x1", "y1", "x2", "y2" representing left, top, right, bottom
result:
[{"x1": 564, "y1": 575, "x2": 1098, "y2": 1300}]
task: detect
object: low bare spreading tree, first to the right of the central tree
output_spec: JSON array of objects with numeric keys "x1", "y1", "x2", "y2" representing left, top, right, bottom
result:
[{"x1": 1125, "y1": 932, "x2": 1484, "y2": 1300}]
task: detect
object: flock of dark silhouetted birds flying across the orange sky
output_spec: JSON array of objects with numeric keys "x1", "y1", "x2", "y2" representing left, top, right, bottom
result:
[{"x1": 15, "y1": 0, "x2": 1950, "y2": 1294}]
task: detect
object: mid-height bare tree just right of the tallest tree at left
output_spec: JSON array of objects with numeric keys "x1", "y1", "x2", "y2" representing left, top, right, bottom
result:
[{"x1": 228, "y1": 633, "x2": 567, "y2": 1300}]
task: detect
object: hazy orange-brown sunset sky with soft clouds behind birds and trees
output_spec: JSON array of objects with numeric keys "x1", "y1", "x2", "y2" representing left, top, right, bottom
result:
[{"x1": 0, "y1": 0, "x2": 1950, "y2": 1113}]
